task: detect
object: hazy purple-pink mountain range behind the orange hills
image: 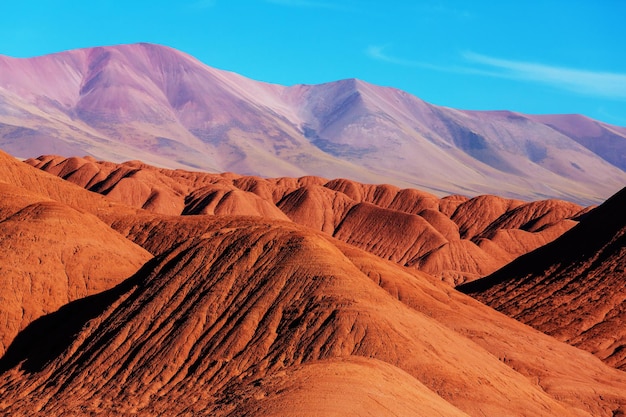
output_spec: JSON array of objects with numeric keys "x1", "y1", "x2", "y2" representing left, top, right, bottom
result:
[{"x1": 0, "y1": 44, "x2": 626, "y2": 204}]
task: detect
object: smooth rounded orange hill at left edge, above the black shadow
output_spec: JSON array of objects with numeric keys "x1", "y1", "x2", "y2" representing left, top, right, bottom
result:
[{"x1": 0, "y1": 198, "x2": 150, "y2": 355}]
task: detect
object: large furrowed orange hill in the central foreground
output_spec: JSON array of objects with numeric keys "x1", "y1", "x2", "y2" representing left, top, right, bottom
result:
[{"x1": 0, "y1": 216, "x2": 626, "y2": 416}]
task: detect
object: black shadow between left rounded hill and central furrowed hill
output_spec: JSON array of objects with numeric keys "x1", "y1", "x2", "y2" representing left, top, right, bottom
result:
[{"x1": 0, "y1": 258, "x2": 157, "y2": 373}]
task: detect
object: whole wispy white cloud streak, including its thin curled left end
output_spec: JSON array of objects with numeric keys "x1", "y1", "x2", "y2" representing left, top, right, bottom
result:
[{"x1": 366, "y1": 45, "x2": 626, "y2": 100}]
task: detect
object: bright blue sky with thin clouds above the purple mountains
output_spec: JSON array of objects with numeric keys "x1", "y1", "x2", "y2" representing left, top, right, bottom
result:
[{"x1": 0, "y1": 0, "x2": 626, "y2": 126}]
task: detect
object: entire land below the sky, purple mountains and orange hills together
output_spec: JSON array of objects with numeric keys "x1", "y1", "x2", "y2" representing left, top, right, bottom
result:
[{"x1": 0, "y1": 42, "x2": 626, "y2": 417}]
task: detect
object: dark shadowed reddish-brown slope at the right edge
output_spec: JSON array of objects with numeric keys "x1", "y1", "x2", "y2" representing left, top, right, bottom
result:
[{"x1": 460, "y1": 189, "x2": 626, "y2": 370}]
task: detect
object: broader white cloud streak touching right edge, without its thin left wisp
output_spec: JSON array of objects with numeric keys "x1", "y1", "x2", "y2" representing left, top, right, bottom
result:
[{"x1": 463, "y1": 52, "x2": 626, "y2": 99}]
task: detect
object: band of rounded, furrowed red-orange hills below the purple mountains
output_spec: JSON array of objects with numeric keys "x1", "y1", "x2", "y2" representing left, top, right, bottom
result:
[{"x1": 26, "y1": 156, "x2": 584, "y2": 284}]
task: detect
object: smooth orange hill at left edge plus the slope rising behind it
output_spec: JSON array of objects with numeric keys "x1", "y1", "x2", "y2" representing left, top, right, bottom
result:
[{"x1": 0, "y1": 154, "x2": 151, "y2": 355}]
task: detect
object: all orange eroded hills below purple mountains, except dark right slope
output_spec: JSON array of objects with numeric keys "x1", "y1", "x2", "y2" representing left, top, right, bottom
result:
[{"x1": 0, "y1": 148, "x2": 626, "y2": 417}]
